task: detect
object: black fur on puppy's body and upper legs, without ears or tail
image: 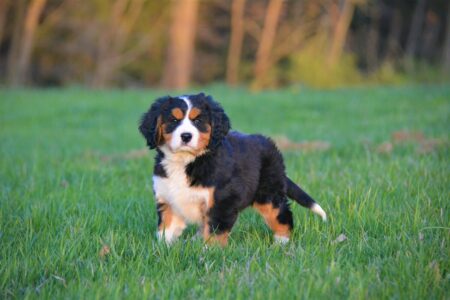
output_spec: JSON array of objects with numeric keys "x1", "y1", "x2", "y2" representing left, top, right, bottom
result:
[{"x1": 186, "y1": 131, "x2": 293, "y2": 233}]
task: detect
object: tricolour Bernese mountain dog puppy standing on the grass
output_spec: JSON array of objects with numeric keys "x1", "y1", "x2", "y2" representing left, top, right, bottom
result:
[{"x1": 139, "y1": 93, "x2": 326, "y2": 246}]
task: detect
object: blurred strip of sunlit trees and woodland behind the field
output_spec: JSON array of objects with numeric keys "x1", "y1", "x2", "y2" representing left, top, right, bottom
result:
[{"x1": 0, "y1": 0, "x2": 450, "y2": 89}]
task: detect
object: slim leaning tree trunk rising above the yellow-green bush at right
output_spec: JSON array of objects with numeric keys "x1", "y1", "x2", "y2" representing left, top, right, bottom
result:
[{"x1": 327, "y1": 0, "x2": 355, "y2": 66}]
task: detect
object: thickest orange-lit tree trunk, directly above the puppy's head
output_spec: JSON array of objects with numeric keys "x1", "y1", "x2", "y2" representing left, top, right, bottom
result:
[{"x1": 162, "y1": 0, "x2": 198, "y2": 89}]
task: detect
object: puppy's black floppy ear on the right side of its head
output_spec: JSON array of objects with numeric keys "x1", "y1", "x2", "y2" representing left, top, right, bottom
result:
[{"x1": 204, "y1": 93, "x2": 231, "y2": 149}]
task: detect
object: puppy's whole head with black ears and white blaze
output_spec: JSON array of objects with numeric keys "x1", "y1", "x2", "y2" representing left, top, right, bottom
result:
[{"x1": 139, "y1": 93, "x2": 230, "y2": 155}]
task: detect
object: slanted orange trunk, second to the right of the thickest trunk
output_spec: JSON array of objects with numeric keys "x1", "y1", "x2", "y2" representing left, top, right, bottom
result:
[{"x1": 252, "y1": 0, "x2": 283, "y2": 88}]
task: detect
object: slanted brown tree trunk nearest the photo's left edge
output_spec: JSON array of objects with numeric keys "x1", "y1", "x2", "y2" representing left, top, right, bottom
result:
[{"x1": 13, "y1": 0, "x2": 47, "y2": 85}]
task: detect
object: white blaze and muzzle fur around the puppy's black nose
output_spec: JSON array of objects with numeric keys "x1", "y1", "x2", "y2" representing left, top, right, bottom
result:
[{"x1": 170, "y1": 96, "x2": 200, "y2": 151}]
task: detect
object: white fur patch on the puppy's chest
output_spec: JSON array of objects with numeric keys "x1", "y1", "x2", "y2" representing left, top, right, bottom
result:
[{"x1": 153, "y1": 151, "x2": 210, "y2": 224}]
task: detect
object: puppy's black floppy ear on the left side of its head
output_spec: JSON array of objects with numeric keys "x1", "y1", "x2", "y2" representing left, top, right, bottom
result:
[{"x1": 139, "y1": 96, "x2": 170, "y2": 149}]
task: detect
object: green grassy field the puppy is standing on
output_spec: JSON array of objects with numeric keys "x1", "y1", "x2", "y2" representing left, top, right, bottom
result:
[{"x1": 0, "y1": 86, "x2": 450, "y2": 299}]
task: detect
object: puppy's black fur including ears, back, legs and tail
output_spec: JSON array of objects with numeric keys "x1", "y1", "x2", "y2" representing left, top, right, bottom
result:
[{"x1": 139, "y1": 93, "x2": 322, "y2": 241}]
